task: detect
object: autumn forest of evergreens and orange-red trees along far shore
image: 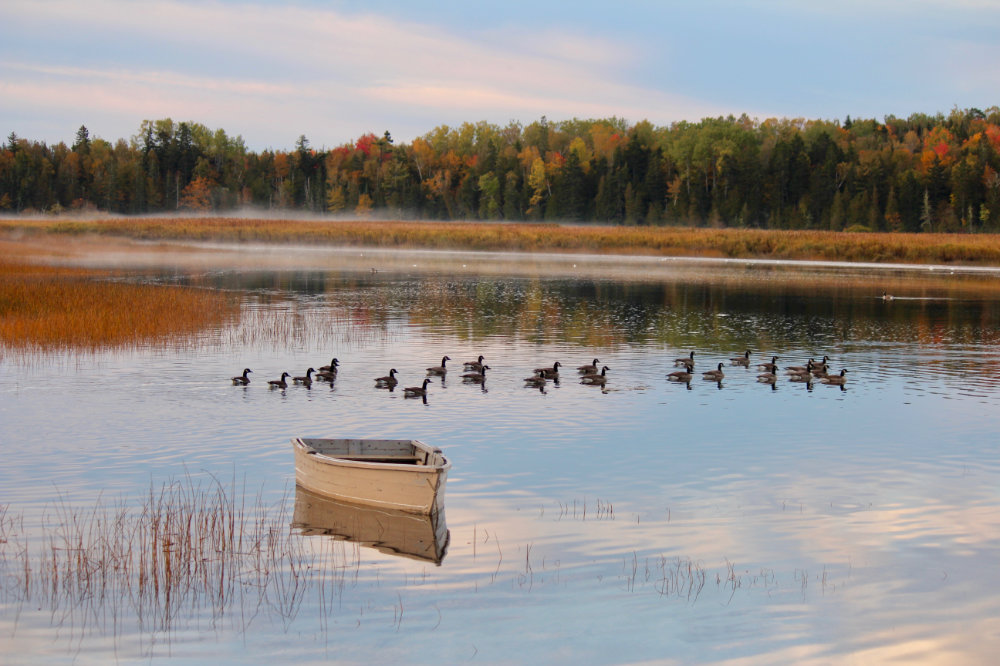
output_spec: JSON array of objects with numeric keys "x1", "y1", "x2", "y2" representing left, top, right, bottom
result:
[{"x1": 0, "y1": 106, "x2": 1000, "y2": 233}]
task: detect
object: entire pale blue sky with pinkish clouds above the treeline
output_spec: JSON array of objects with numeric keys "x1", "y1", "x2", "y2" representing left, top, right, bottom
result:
[{"x1": 0, "y1": 0, "x2": 1000, "y2": 150}]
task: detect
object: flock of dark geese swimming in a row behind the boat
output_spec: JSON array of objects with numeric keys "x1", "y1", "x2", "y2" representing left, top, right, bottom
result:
[{"x1": 232, "y1": 349, "x2": 847, "y2": 398}]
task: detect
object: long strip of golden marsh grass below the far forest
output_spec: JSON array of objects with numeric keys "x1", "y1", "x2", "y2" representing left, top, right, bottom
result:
[{"x1": 0, "y1": 218, "x2": 1000, "y2": 266}]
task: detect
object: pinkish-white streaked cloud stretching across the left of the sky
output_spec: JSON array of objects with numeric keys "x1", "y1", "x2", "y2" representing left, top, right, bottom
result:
[{"x1": 0, "y1": 0, "x2": 722, "y2": 145}]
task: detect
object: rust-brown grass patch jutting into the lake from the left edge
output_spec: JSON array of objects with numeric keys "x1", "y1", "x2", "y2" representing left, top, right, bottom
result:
[{"x1": 0, "y1": 249, "x2": 239, "y2": 351}]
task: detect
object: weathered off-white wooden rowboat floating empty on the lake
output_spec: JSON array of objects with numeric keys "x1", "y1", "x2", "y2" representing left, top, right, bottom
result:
[{"x1": 292, "y1": 437, "x2": 451, "y2": 514}]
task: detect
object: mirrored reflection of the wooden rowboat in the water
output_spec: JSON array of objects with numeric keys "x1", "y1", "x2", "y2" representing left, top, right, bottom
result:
[{"x1": 292, "y1": 484, "x2": 450, "y2": 566}]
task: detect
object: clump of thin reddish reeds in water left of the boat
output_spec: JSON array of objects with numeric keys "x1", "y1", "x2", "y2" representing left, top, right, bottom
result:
[{"x1": 0, "y1": 479, "x2": 360, "y2": 633}]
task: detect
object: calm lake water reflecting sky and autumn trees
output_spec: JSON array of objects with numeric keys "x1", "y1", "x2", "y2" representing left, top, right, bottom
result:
[{"x1": 0, "y1": 248, "x2": 1000, "y2": 664}]
